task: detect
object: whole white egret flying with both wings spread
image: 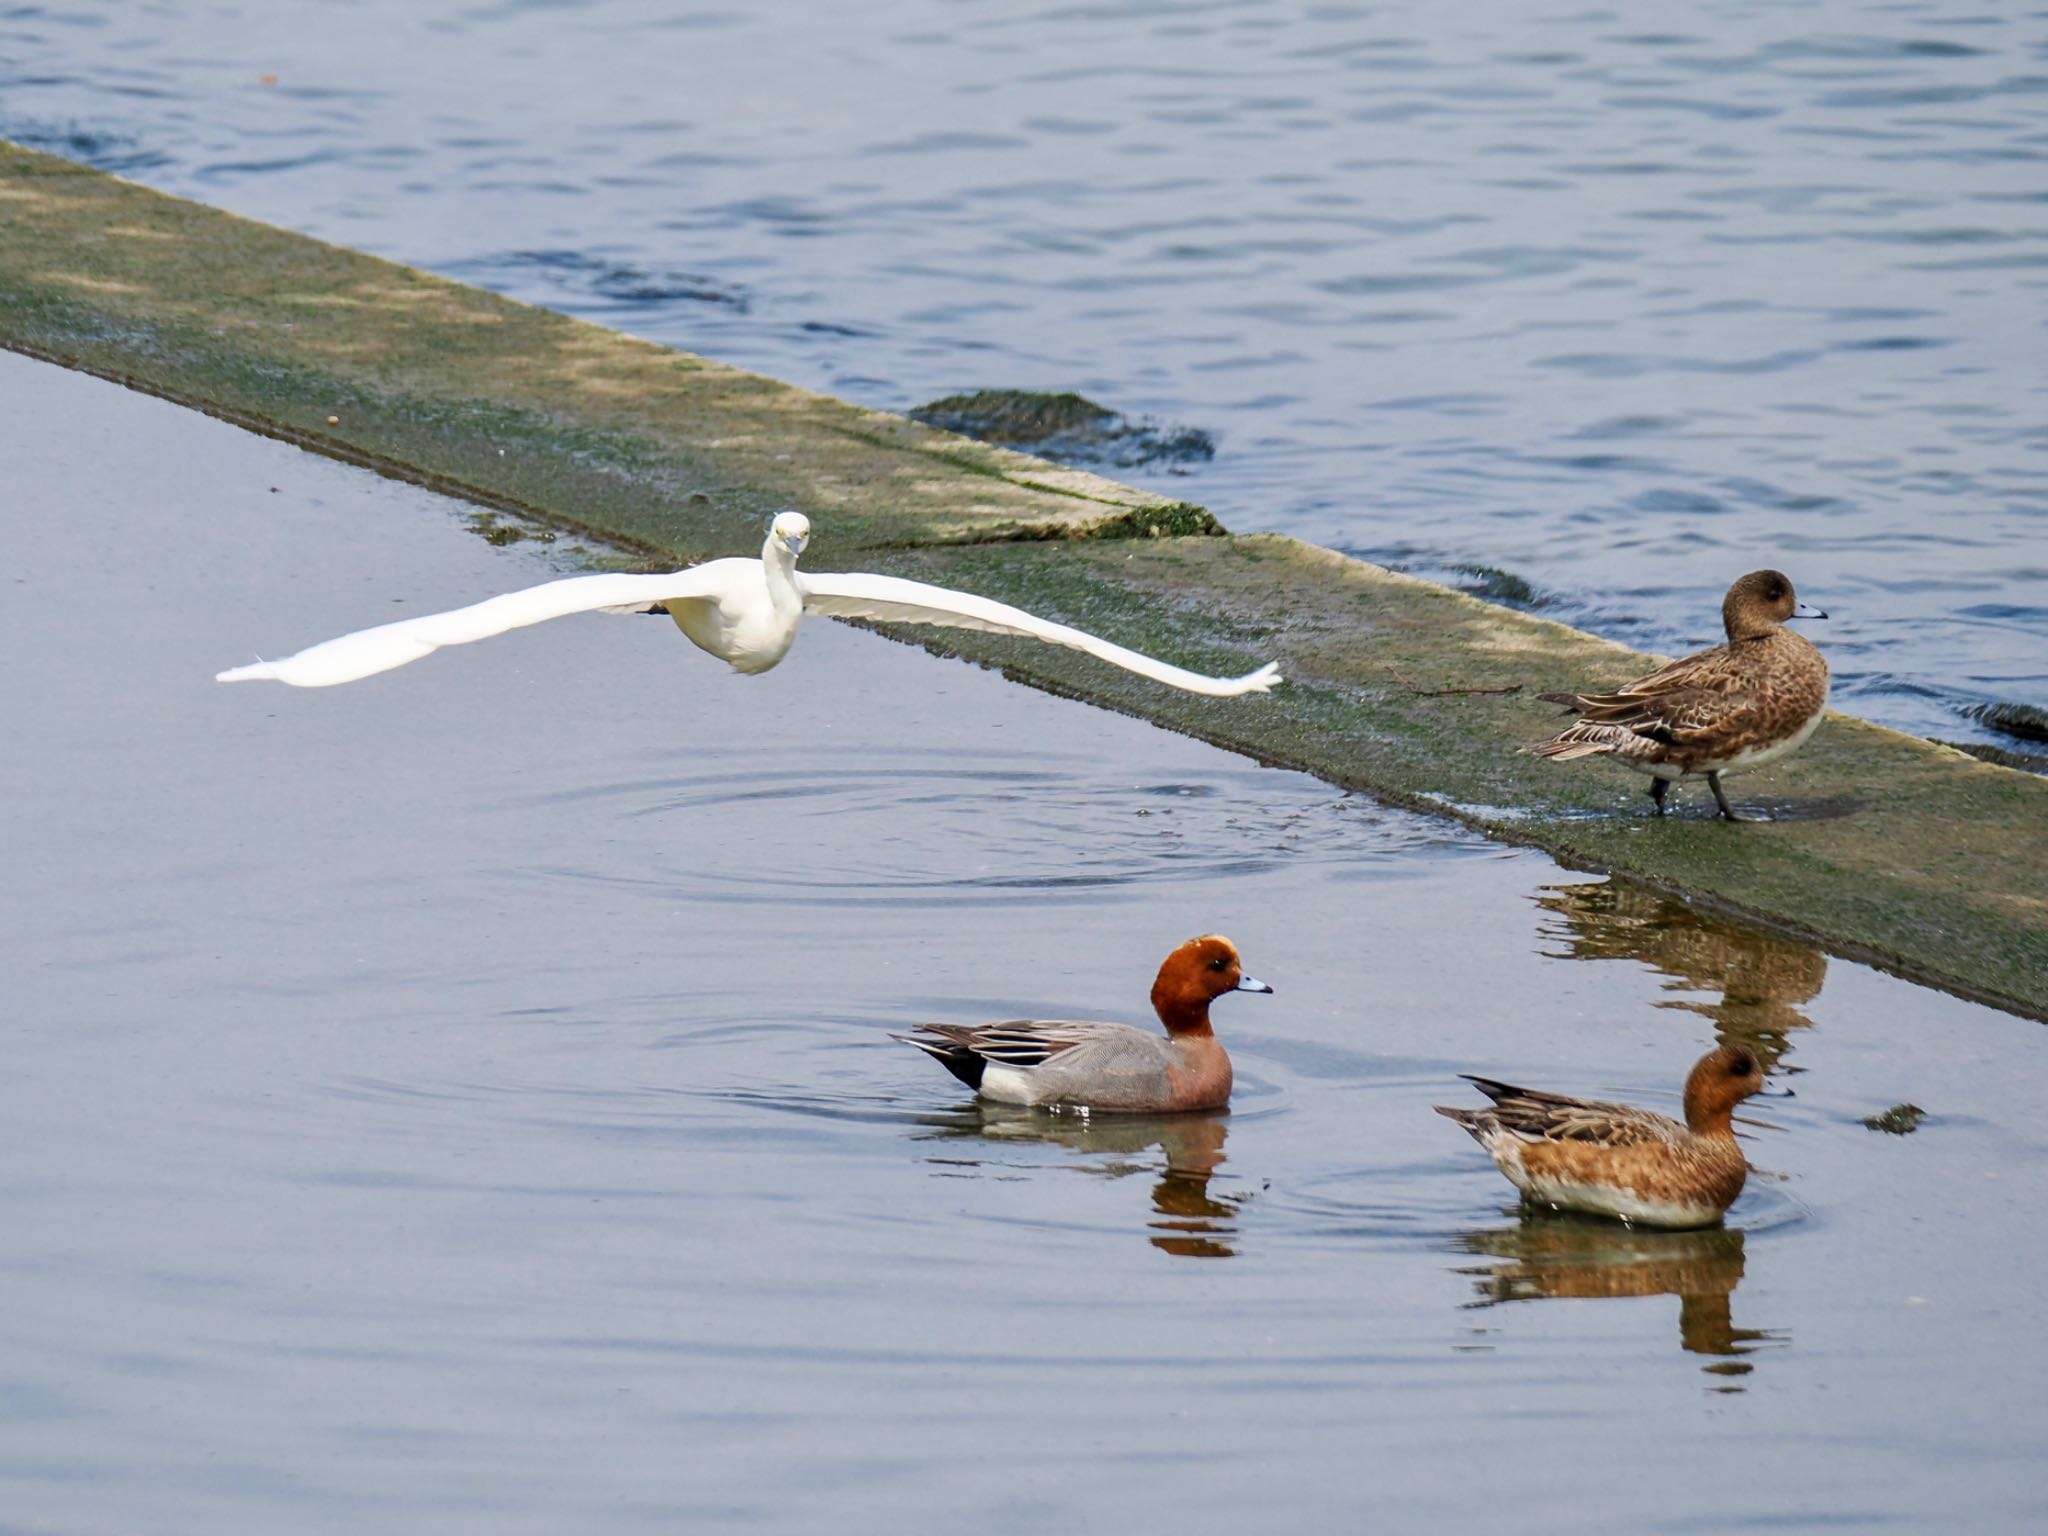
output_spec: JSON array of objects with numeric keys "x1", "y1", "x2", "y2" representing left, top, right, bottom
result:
[{"x1": 217, "y1": 512, "x2": 1280, "y2": 696}]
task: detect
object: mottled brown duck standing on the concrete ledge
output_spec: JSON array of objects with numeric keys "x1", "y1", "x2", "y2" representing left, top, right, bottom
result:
[{"x1": 1530, "y1": 571, "x2": 1827, "y2": 821}]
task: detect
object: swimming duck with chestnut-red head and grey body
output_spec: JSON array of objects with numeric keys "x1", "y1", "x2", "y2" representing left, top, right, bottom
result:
[{"x1": 895, "y1": 934, "x2": 1272, "y2": 1114}]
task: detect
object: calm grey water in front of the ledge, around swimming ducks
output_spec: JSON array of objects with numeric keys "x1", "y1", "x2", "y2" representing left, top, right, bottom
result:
[{"x1": 0, "y1": 354, "x2": 2048, "y2": 1536}]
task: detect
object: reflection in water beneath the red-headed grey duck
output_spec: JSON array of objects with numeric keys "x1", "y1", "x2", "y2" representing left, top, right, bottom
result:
[{"x1": 918, "y1": 1102, "x2": 1251, "y2": 1260}]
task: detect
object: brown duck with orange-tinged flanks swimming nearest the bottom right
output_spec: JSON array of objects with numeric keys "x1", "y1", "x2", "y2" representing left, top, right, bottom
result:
[{"x1": 1436, "y1": 1044, "x2": 1792, "y2": 1227}]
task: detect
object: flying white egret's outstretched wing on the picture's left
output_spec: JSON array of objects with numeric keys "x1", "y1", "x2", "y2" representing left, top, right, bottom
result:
[{"x1": 215, "y1": 561, "x2": 729, "y2": 688}]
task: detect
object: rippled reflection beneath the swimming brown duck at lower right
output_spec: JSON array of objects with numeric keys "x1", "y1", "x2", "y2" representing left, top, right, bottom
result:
[{"x1": 1452, "y1": 1212, "x2": 1788, "y2": 1393}]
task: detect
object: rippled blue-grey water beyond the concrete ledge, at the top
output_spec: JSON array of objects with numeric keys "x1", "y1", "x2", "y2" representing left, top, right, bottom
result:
[{"x1": 0, "y1": 0, "x2": 2048, "y2": 737}]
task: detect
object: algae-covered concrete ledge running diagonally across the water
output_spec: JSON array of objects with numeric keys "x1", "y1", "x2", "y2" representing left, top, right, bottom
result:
[{"x1": 0, "y1": 143, "x2": 2048, "y2": 1018}]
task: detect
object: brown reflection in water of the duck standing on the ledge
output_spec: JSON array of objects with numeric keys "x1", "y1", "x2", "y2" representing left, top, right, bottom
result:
[{"x1": 1536, "y1": 881, "x2": 1827, "y2": 1069}]
